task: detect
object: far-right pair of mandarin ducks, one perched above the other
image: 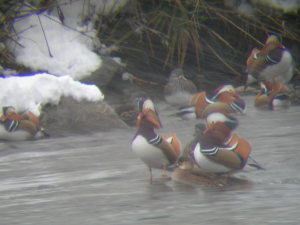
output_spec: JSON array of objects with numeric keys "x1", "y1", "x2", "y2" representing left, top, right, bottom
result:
[{"x1": 246, "y1": 35, "x2": 294, "y2": 109}]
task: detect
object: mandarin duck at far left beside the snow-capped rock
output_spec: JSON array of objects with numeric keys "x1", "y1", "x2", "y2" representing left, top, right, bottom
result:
[{"x1": 0, "y1": 106, "x2": 48, "y2": 141}]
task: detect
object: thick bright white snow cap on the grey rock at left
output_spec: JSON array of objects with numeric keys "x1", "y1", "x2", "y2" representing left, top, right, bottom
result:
[{"x1": 0, "y1": 73, "x2": 104, "y2": 116}]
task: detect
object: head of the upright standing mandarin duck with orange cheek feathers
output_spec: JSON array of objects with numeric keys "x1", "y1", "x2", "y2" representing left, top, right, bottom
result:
[{"x1": 137, "y1": 98, "x2": 162, "y2": 129}]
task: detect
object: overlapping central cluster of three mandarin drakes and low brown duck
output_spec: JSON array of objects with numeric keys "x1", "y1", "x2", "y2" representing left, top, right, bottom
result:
[{"x1": 131, "y1": 85, "x2": 251, "y2": 185}]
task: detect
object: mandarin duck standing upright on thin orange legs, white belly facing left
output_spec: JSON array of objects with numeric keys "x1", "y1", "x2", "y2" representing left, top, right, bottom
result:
[{"x1": 131, "y1": 98, "x2": 181, "y2": 181}]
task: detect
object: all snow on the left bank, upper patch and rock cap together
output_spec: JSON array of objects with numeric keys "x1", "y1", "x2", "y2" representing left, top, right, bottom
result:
[{"x1": 0, "y1": 0, "x2": 128, "y2": 116}]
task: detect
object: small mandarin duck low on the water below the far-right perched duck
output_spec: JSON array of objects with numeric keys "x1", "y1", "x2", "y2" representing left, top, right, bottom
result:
[{"x1": 254, "y1": 80, "x2": 291, "y2": 109}]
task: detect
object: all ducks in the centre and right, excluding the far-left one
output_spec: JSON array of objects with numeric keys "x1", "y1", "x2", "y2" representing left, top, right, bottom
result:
[{"x1": 131, "y1": 35, "x2": 293, "y2": 184}]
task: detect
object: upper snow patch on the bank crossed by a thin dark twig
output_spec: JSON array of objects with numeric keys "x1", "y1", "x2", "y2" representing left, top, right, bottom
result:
[{"x1": 10, "y1": 12, "x2": 101, "y2": 79}]
